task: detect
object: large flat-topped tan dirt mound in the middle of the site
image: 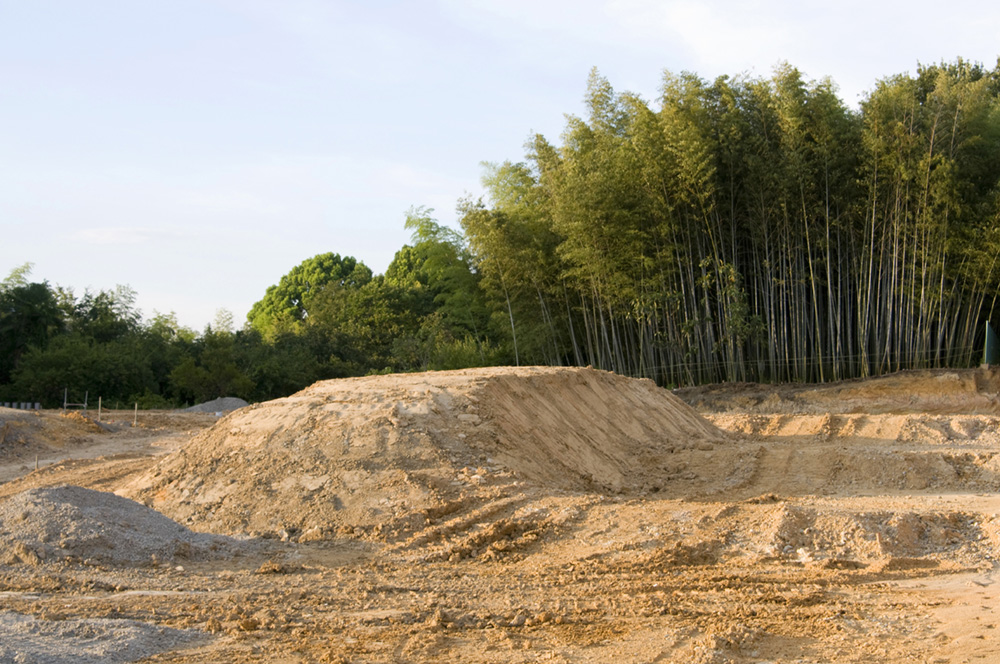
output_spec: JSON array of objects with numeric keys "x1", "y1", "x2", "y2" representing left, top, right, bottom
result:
[{"x1": 126, "y1": 367, "x2": 727, "y2": 540}]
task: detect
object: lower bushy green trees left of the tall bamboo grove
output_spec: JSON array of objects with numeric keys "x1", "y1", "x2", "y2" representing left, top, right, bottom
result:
[{"x1": 0, "y1": 208, "x2": 506, "y2": 408}]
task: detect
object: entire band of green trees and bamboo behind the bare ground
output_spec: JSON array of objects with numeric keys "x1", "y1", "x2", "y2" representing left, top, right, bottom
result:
[{"x1": 0, "y1": 60, "x2": 1000, "y2": 406}]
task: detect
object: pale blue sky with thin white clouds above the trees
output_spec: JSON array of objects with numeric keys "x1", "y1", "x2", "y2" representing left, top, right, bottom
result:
[{"x1": 0, "y1": 0, "x2": 1000, "y2": 331}]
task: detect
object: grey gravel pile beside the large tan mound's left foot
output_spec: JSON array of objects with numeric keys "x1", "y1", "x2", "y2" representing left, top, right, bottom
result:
[{"x1": 0, "y1": 486, "x2": 244, "y2": 565}]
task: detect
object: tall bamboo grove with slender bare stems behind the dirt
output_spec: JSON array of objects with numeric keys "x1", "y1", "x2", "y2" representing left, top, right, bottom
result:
[{"x1": 459, "y1": 60, "x2": 1000, "y2": 384}]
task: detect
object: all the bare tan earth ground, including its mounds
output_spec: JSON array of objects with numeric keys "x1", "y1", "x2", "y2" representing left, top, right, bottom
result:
[{"x1": 0, "y1": 368, "x2": 1000, "y2": 664}]
